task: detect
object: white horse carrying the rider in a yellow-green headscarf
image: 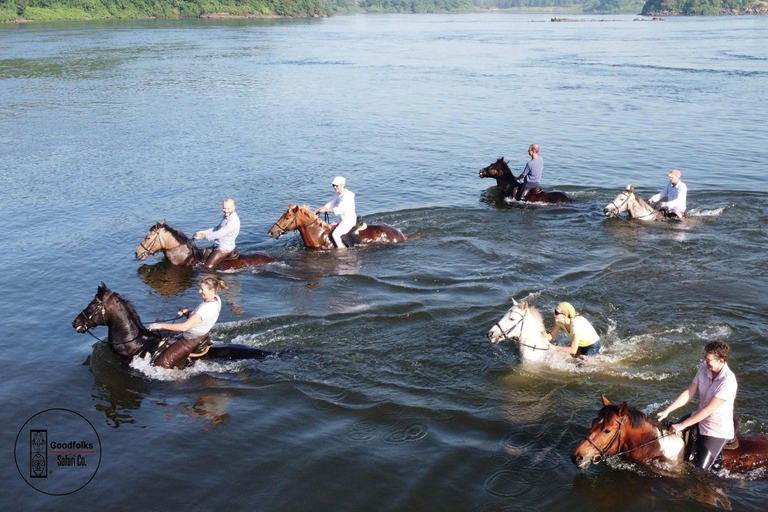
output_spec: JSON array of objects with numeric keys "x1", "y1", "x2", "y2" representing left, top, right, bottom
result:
[{"x1": 488, "y1": 299, "x2": 553, "y2": 361}]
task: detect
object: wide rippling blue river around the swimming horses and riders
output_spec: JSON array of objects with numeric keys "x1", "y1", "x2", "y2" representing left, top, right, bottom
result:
[{"x1": 0, "y1": 14, "x2": 768, "y2": 512}]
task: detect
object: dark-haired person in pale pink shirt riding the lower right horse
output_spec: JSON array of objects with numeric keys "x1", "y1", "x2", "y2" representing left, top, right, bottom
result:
[{"x1": 658, "y1": 341, "x2": 738, "y2": 469}]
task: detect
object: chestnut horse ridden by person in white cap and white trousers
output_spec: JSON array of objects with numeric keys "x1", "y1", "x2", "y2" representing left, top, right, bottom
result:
[{"x1": 269, "y1": 203, "x2": 405, "y2": 249}]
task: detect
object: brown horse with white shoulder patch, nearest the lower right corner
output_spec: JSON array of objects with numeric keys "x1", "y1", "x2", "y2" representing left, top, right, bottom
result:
[{"x1": 571, "y1": 396, "x2": 768, "y2": 473}]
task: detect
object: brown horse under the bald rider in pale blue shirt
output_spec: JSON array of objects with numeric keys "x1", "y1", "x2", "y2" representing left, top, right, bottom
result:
[{"x1": 134, "y1": 222, "x2": 276, "y2": 270}]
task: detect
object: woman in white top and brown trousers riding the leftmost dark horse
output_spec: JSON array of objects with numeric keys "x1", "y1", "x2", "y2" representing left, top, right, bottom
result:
[{"x1": 148, "y1": 276, "x2": 224, "y2": 368}]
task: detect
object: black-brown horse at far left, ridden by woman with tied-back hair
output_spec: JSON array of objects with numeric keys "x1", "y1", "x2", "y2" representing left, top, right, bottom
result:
[{"x1": 72, "y1": 283, "x2": 278, "y2": 368}]
